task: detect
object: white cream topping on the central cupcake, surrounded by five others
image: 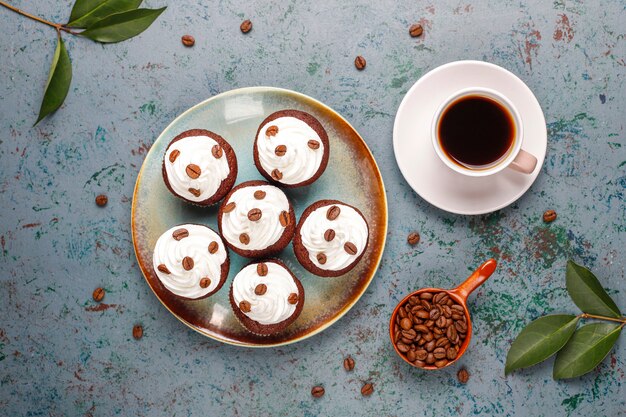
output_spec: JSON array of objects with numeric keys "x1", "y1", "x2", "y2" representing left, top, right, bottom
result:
[{"x1": 222, "y1": 185, "x2": 289, "y2": 250}]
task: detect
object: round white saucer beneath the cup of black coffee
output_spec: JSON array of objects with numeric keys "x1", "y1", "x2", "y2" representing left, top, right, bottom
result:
[{"x1": 393, "y1": 61, "x2": 548, "y2": 214}]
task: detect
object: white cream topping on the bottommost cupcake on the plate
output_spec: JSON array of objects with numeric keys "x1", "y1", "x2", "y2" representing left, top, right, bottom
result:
[{"x1": 233, "y1": 262, "x2": 302, "y2": 325}]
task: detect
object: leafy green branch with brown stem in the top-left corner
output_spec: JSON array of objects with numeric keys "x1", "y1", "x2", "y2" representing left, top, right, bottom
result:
[{"x1": 0, "y1": 0, "x2": 166, "y2": 124}]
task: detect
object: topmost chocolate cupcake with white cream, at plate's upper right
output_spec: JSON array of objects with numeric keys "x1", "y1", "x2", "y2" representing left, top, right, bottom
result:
[{"x1": 254, "y1": 110, "x2": 330, "y2": 187}]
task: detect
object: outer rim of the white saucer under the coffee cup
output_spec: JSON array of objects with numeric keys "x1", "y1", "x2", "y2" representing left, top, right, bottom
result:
[{"x1": 393, "y1": 59, "x2": 548, "y2": 216}]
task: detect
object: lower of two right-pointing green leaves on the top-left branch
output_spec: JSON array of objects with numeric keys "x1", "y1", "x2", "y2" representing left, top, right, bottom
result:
[{"x1": 80, "y1": 7, "x2": 166, "y2": 43}]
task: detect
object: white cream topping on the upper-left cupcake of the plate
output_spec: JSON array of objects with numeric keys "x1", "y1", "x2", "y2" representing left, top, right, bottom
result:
[{"x1": 165, "y1": 136, "x2": 230, "y2": 202}]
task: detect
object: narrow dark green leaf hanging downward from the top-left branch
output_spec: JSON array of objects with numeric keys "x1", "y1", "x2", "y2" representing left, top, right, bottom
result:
[{"x1": 35, "y1": 35, "x2": 72, "y2": 124}]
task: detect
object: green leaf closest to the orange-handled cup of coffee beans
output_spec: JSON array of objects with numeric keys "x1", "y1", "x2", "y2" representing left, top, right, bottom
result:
[{"x1": 504, "y1": 314, "x2": 578, "y2": 375}]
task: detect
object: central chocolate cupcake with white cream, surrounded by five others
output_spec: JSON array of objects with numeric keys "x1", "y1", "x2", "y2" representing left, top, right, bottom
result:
[{"x1": 217, "y1": 181, "x2": 296, "y2": 258}]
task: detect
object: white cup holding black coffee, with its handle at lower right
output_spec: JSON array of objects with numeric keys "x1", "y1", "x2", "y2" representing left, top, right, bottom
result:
[{"x1": 431, "y1": 87, "x2": 537, "y2": 177}]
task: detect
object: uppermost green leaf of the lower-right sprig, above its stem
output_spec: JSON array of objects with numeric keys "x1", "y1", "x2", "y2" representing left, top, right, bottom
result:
[{"x1": 565, "y1": 261, "x2": 622, "y2": 318}]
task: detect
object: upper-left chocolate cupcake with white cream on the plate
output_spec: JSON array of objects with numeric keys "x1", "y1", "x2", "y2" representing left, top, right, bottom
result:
[{"x1": 162, "y1": 129, "x2": 237, "y2": 206}]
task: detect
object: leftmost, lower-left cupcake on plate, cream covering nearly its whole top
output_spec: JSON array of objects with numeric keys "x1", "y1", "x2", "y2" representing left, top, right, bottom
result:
[{"x1": 152, "y1": 224, "x2": 230, "y2": 300}]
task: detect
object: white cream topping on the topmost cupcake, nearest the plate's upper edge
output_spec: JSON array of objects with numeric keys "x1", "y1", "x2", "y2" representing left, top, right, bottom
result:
[{"x1": 256, "y1": 117, "x2": 324, "y2": 184}]
